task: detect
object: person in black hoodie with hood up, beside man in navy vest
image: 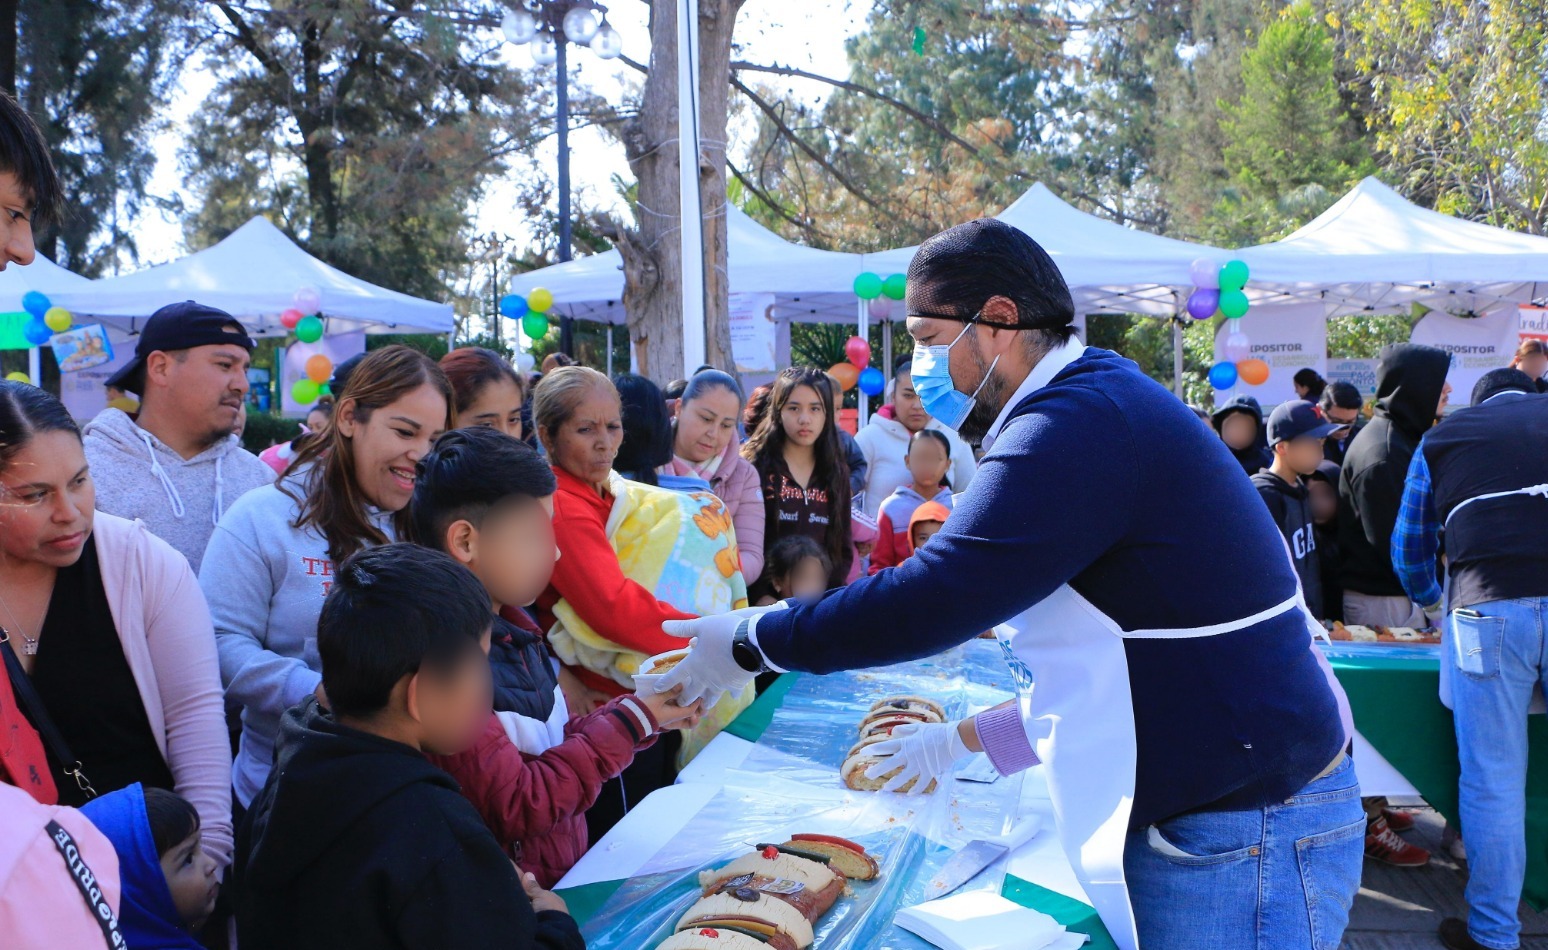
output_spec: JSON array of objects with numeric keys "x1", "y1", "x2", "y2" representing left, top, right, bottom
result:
[{"x1": 1339, "y1": 343, "x2": 1450, "y2": 627}]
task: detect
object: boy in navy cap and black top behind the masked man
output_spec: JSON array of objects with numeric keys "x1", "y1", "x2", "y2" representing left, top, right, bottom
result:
[{"x1": 1252, "y1": 399, "x2": 1342, "y2": 617}]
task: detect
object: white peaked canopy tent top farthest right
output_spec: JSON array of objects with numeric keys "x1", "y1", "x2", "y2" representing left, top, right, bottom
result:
[{"x1": 1232, "y1": 178, "x2": 1548, "y2": 317}]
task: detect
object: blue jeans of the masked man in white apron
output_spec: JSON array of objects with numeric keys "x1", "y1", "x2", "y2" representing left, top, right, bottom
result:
[{"x1": 1124, "y1": 757, "x2": 1365, "y2": 950}]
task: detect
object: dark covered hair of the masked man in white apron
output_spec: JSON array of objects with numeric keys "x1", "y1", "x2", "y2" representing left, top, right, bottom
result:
[{"x1": 909, "y1": 218, "x2": 1074, "y2": 345}]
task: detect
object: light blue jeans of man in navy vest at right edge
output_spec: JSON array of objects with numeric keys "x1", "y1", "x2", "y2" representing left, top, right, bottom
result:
[{"x1": 1446, "y1": 597, "x2": 1548, "y2": 950}]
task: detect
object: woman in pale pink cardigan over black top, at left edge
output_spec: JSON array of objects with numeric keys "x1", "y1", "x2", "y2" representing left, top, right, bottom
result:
[{"x1": 0, "y1": 381, "x2": 232, "y2": 866}]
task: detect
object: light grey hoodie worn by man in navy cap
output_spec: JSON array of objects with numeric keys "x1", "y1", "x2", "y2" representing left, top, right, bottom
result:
[{"x1": 84, "y1": 408, "x2": 274, "y2": 572}]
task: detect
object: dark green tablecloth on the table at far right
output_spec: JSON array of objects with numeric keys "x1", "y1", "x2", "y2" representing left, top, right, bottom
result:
[{"x1": 1328, "y1": 656, "x2": 1548, "y2": 910}]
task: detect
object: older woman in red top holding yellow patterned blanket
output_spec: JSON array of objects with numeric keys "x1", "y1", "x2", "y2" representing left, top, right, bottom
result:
[{"x1": 533, "y1": 367, "x2": 751, "y2": 842}]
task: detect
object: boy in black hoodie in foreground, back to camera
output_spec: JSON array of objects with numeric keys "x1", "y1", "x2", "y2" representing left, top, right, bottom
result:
[{"x1": 234, "y1": 545, "x2": 585, "y2": 950}]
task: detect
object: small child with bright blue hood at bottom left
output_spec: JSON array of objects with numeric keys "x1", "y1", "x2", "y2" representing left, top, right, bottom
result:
[{"x1": 80, "y1": 781, "x2": 220, "y2": 950}]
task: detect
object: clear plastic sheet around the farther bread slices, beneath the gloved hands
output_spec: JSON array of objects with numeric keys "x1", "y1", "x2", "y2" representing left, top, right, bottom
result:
[{"x1": 738, "y1": 641, "x2": 1015, "y2": 788}]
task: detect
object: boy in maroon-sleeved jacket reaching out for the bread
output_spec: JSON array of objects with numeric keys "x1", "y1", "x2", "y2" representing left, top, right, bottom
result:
[{"x1": 413, "y1": 427, "x2": 698, "y2": 887}]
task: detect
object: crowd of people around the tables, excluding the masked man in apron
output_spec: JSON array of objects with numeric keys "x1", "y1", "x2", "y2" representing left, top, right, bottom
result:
[{"x1": 0, "y1": 85, "x2": 1548, "y2": 950}]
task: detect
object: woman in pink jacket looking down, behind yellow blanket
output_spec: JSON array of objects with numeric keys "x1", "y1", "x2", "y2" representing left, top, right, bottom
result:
[{"x1": 661, "y1": 370, "x2": 763, "y2": 585}]
